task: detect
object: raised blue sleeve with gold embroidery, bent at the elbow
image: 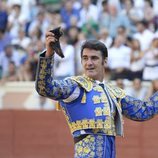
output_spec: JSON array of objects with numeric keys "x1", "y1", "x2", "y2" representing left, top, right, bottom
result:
[{"x1": 36, "y1": 52, "x2": 78, "y2": 100}]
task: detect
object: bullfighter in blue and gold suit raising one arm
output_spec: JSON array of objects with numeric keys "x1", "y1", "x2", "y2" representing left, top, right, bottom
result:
[{"x1": 36, "y1": 32, "x2": 158, "y2": 158}]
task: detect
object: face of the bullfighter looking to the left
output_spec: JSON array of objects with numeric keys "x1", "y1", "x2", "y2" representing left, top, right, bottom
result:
[{"x1": 81, "y1": 48, "x2": 105, "y2": 81}]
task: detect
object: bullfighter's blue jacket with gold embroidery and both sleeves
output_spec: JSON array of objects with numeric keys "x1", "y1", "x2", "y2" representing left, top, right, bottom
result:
[{"x1": 36, "y1": 53, "x2": 158, "y2": 136}]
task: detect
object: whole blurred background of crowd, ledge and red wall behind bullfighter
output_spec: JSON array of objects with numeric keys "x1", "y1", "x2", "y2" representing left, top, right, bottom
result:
[{"x1": 0, "y1": 0, "x2": 158, "y2": 158}]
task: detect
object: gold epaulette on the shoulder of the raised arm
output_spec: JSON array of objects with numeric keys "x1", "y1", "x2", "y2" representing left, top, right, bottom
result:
[{"x1": 70, "y1": 76, "x2": 93, "y2": 92}]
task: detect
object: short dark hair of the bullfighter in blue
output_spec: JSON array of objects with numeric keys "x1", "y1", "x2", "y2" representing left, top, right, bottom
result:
[{"x1": 81, "y1": 40, "x2": 108, "y2": 59}]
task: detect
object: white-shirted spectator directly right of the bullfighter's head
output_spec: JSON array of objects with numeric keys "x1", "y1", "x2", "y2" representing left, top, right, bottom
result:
[{"x1": 108, "y1": 36, "x2": 131, "y2": 80}]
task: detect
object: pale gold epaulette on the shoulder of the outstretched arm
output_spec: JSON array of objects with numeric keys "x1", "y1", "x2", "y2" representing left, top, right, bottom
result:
[{"x1": 106, "y1": 82, "x2": 126, "y2": 99}]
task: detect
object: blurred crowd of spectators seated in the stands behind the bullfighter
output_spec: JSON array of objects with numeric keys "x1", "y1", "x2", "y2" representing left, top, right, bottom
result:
[{"x1": 0, "y1": 0, "x2": 158, "y2": 101}]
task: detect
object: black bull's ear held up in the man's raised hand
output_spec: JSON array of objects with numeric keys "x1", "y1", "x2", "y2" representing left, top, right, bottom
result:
[{"x1": 50, "y1": 27, "x2": 64, "y2": 58}]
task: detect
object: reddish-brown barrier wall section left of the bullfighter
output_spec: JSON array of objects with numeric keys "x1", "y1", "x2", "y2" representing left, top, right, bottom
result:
[{"x1": 0, "y1": 110, "x2": 73, "y2": 158}]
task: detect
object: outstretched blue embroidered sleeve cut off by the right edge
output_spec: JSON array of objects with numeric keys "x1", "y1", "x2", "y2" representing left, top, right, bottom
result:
[{"x1": 121, "y1": 92, "x2": 158, "y2": 121}]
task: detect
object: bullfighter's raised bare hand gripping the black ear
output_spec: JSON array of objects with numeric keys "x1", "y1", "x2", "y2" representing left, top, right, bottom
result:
[{"x1": 45, "y1": 31, "x2": 57, "y2": 57}]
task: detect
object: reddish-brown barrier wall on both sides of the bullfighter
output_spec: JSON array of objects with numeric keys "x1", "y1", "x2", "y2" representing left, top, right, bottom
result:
[{"x1": 0, "y1": 110, "x2": 158, "y2": 158}]
